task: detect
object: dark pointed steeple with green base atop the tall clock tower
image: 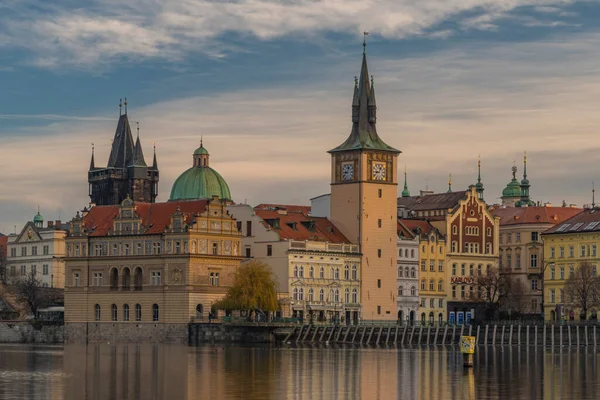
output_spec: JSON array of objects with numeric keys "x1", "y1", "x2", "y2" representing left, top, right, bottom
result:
[{"x1": 329, "y1": 39, "x2": 400, "y2": 154}]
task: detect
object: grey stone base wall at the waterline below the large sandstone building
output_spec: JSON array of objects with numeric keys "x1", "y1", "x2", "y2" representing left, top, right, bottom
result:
[{"x1": 65, "y1": 322, "x2": 188, "y2": 344}]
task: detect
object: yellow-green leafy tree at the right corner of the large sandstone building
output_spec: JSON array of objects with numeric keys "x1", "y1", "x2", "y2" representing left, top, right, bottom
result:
[{"x1": 213, "y1": 261, "x2": 279, "y2": 317}]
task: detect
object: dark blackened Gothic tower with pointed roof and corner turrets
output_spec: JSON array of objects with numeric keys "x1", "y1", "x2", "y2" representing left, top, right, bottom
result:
[{"x1": 88, "y1": 100, "x2": 159, "y2": 206}]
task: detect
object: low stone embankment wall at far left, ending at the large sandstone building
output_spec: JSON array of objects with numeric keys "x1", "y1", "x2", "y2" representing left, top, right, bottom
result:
[{"x1": 0, "y1": 321, "x2": 65, "y2": 344}]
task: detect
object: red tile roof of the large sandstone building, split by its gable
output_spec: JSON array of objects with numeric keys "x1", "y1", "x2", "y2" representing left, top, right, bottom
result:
[{"x1": 84, "y1": 200, "x2": 208, "y2": 236}]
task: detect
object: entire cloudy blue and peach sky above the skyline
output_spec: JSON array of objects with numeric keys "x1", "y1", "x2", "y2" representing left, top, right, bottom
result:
[{"x1": 0, "y1": 0, "x2": 600, "y2": 233}]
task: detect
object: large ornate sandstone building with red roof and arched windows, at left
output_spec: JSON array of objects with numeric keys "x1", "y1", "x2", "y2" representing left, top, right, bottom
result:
[{"x1": 65, "y1": 197, "x2": 242, "y2": 343}]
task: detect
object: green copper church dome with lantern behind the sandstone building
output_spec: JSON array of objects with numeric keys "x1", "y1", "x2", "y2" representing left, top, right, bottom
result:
[{"x1": 169, "y1": 144, "x2": 231, "y2": 201}]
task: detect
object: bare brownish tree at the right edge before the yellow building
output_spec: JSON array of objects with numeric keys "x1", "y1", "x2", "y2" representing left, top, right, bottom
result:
[{"x1": 565, "y1": 262, "x2": 600, "y2": 319}]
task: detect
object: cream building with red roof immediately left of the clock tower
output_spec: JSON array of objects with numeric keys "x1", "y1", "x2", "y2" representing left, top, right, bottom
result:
[{"x1": 227, "y1": 204, "x2": 361, "y2": 323}]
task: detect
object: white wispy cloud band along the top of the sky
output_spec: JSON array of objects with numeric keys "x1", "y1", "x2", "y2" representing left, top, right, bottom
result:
[{"x1": 0, "y1": 0, "x2": 570, "y2": 69}]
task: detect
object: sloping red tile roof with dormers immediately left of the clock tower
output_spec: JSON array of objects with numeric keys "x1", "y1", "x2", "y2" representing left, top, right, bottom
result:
[{"x1": 254, "y1": 208, "x2": 350, "y2": 243}]
